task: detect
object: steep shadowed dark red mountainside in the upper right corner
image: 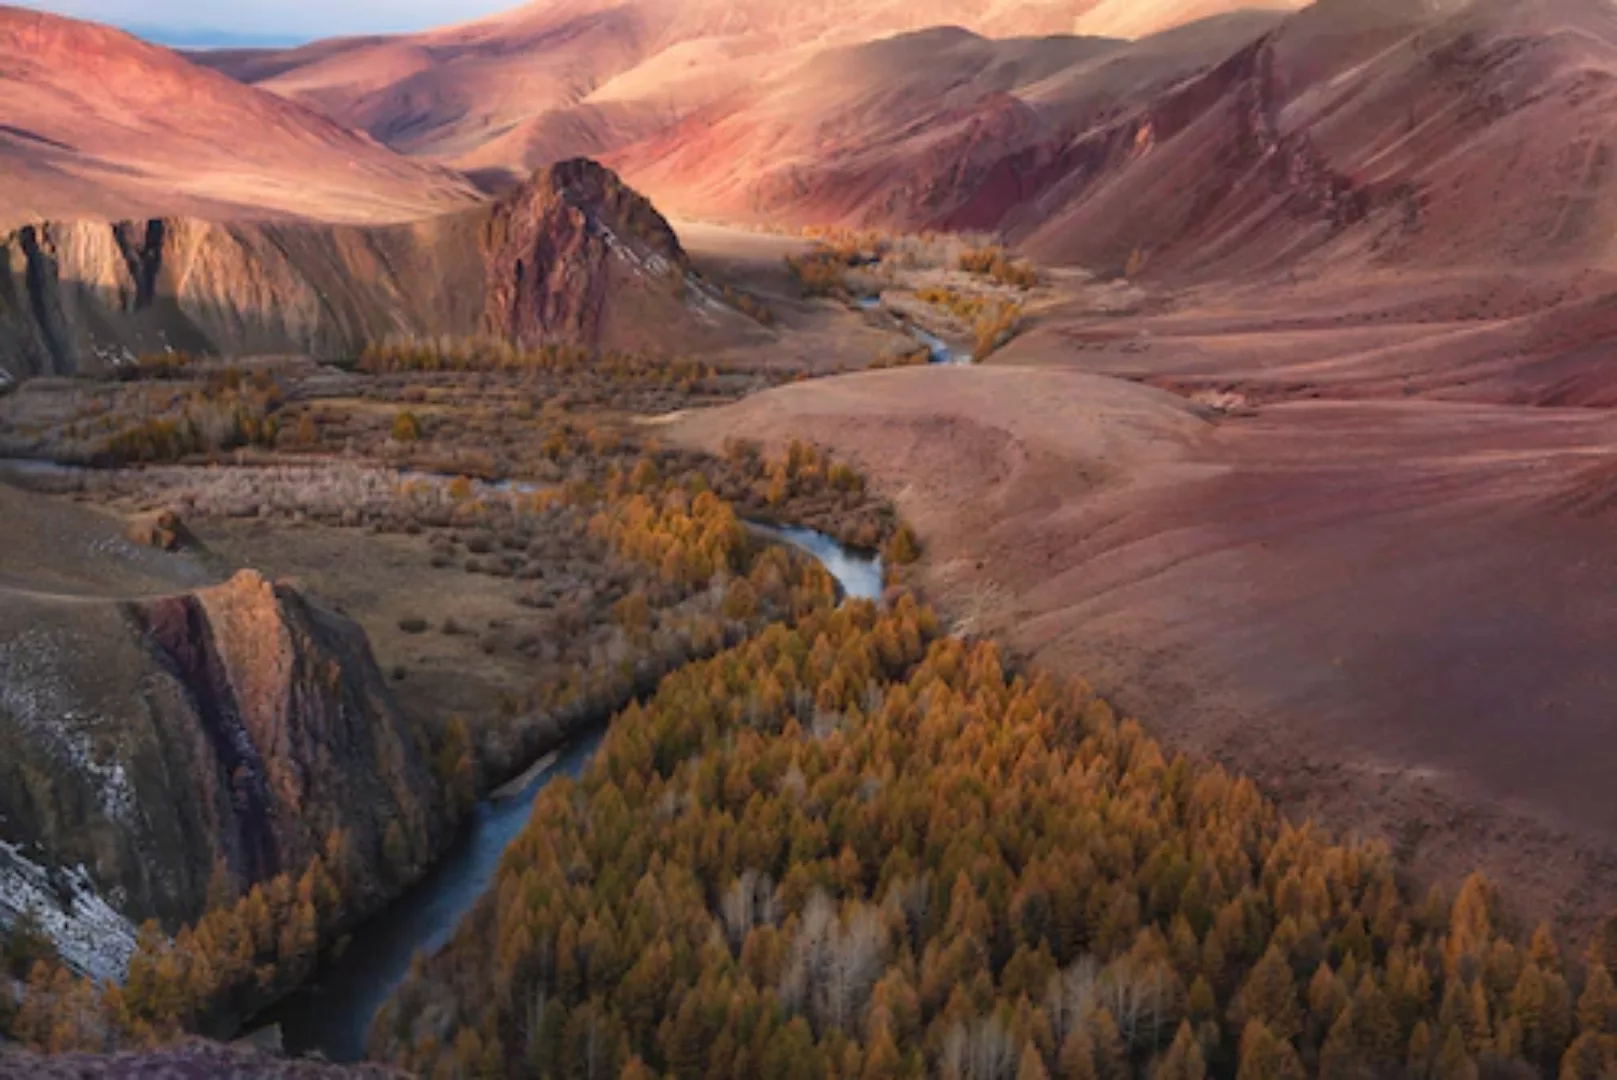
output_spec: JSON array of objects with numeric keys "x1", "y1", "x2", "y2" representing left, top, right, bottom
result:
[{"x1": 1012, "y1": 0, "x2": 1617, "y2": 280}]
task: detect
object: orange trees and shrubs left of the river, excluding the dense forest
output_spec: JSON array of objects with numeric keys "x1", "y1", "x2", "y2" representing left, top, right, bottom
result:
[{"x1": 0, "y1": 344, "x2": 915, "y2": 1053}]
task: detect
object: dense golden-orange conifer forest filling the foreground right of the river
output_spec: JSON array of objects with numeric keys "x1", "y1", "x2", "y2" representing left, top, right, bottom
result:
[{"x1": 372, "y1": 598, "x2": 1617, "y2": 1080}]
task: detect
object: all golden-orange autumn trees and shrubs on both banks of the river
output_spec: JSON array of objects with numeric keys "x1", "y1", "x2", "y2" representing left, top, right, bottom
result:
[{"x1": 0, "y1": 329, "x2": 1617, "y2": 1080}]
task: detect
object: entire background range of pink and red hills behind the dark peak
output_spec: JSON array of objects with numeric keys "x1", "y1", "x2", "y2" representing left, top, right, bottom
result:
[{"x1": 154, "y1": 0, "x2": 1617, "y2": 292}]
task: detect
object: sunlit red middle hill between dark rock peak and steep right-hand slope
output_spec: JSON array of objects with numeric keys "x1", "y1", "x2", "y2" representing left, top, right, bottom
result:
[{"x1": 610, "y1": 15, "x2": 1273, "y2": 230}]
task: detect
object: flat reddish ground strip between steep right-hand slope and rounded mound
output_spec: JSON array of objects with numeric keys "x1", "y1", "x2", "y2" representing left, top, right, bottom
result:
[{"x1": 996, "y1": 267, "x2": 1617, "y2": 407}]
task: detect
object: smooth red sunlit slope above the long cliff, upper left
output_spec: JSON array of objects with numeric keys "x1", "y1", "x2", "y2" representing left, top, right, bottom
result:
[{"x1": 0, "y1": 6, "x2": 475, "y2": 226}]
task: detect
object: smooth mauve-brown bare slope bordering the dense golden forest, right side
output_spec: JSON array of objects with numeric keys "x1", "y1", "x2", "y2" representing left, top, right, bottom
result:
[{"x1": 674, "y1": 360, "x2": 1617, "y2": 923}]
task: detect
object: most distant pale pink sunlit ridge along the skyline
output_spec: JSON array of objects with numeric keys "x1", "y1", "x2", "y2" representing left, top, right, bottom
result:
[{"x1": 196, "y1": 0, "x2": 1295, "y2": 178}]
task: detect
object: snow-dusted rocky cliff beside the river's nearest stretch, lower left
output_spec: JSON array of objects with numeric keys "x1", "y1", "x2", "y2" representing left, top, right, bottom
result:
[{"x1": 0, "y1": 571, "x2": 448, "y2": 975}]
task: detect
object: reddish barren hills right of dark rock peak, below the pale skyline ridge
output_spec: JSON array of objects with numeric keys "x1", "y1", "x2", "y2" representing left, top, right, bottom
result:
[{"x1": 610, "y1": 0, "x2": 1617, "y2": 280}]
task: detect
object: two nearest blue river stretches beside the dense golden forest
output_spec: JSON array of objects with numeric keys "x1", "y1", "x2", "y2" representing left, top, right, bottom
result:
[{"x1": 254, "y1": 525, "x2": 883, "y2": 1062}]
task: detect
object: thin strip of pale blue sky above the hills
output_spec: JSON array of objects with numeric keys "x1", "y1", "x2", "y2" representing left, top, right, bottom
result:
[{"x1": 13, "y1": 0, "x2": 519, "y2": 40}]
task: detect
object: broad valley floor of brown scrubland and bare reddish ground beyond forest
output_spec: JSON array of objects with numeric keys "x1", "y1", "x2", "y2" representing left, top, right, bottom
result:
[{"x1": 0, "y1": 226, "x2": 1617, "y2": 1067}]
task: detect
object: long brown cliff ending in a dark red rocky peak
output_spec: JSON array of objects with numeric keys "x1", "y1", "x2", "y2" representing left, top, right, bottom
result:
[{"x1": 0, "y1": 160, "x2": 723, "y2": 377}]
